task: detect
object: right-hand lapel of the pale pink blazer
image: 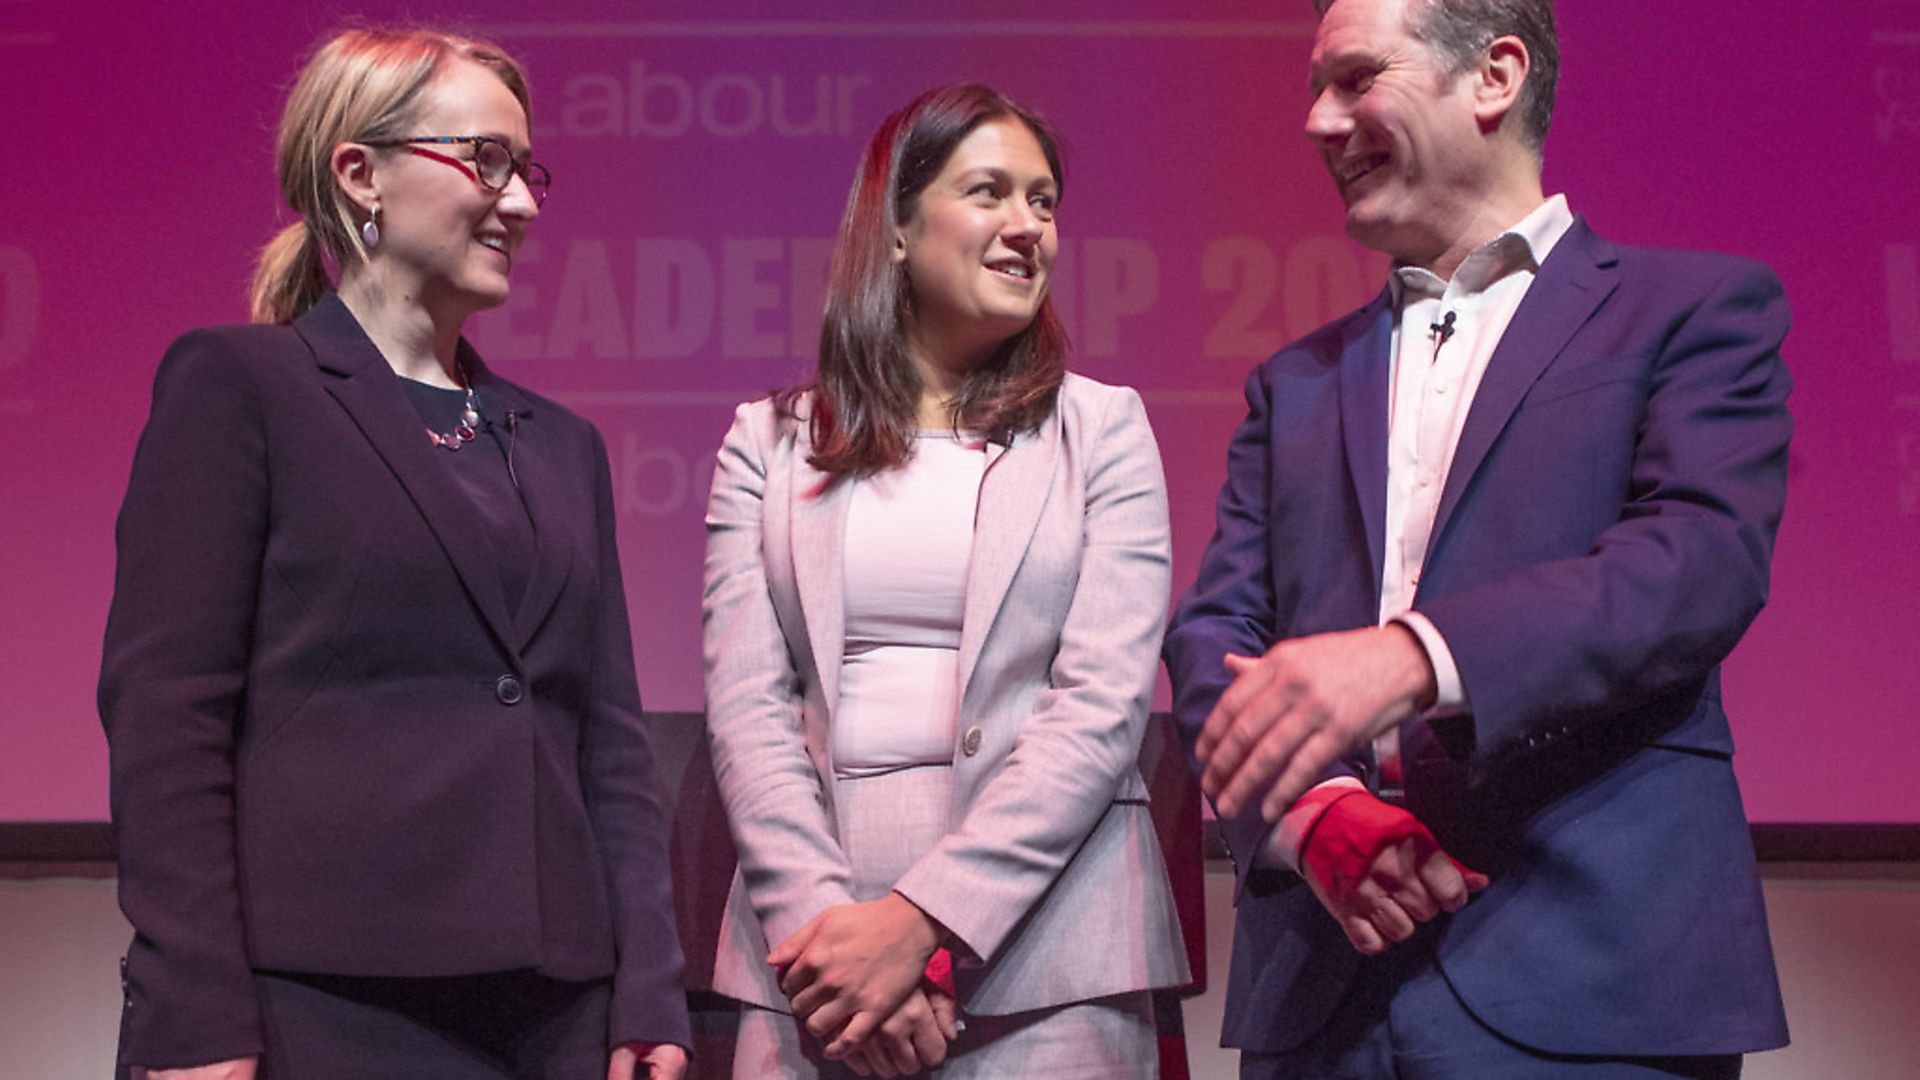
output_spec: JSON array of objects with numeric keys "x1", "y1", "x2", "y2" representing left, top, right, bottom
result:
[{"x1": 960, "y1": 409, "x2": 1060, "y2": 701}]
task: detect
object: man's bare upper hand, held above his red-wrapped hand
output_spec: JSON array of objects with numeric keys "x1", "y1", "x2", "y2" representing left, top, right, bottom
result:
[{"x1": 1194, "y1": 623, "x2": 1434, "y2": 822}]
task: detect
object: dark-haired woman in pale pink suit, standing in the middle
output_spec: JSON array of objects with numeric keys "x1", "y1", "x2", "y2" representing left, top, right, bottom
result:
[{"x1": 705, "y1": 86, "x2": 1187, "y2": 1080}]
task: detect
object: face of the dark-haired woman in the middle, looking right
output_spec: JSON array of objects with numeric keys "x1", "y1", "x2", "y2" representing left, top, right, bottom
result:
[{"x1": 893, "y1": 117, "x2": 1060, "y2": 371}]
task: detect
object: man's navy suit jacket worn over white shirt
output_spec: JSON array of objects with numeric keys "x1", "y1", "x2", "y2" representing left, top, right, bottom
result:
[{"x1": 1165, "y1": 221, "x2": 1791, "y2": 1055}]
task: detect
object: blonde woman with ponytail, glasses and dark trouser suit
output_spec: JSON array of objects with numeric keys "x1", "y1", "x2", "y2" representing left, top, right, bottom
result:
[{"x1": 100, "y1": 29, "x2": 689, "y2": 1080}]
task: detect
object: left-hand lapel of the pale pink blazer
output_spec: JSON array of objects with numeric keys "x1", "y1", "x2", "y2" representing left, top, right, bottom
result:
[{"x1": 787, "y1": 421, "x2": 852, "y2": 711}]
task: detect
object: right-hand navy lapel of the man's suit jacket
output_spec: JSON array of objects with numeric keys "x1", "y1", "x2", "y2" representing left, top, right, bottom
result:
[{"x1": 1427, "y1": 219, "x2": 1619, "y2": 561}]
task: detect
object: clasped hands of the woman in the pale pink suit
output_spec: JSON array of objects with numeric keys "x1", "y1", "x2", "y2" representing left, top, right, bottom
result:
[{"x1": 766, "y1": 894, "x2": 958, "y2": 1076}]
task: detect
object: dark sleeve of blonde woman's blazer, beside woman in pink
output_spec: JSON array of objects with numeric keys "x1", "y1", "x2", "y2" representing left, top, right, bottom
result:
[{"x1": 582, "y1": 422, "x2": 693, "y2": 1047}]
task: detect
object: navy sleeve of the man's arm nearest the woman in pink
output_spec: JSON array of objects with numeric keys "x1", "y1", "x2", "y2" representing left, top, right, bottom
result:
[{"x1": 1164, "y1": 365, "x2": 1356, "y2": 886}]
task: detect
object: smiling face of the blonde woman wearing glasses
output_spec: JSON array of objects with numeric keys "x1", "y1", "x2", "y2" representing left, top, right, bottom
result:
[{"x1": 372, "y1": 60, "x2": 540, "y2": 323}]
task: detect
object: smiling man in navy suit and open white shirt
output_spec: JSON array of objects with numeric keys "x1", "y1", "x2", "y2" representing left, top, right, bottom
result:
[{"x1": 1165, "y1": 0, "x2": 1791, "y2": 1080}]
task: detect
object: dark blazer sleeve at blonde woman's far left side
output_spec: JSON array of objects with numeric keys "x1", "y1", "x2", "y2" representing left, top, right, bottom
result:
[{"x1": 100, "y1": 332, "x2": 269, "y2": 1067}]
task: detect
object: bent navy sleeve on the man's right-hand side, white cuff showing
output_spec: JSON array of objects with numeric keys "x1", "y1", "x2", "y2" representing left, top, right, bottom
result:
[{"x1": 1415, "y1": 253, "x2": 1791, "y2": 759}]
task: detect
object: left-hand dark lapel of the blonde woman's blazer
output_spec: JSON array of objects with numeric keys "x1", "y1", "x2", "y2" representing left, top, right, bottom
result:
[{"x1": 294, "y1": 294, "x2": 518, "y2": 655}]
